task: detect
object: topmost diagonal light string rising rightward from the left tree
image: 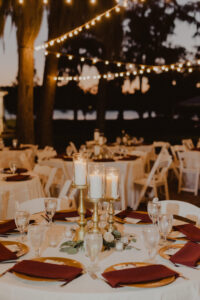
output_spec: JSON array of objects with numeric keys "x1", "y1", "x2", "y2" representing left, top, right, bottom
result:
[{"x1": 35, "y1": 4, "x2": 124, "y2": 51}]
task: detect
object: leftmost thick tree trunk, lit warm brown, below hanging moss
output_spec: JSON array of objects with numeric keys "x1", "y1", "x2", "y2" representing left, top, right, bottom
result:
[{"x1": 17, "y1": 42, "x2": 34, "y2": 144}]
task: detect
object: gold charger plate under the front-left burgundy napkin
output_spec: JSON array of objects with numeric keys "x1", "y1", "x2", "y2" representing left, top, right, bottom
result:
[{"x1": 13, "y1": 257, "x2": 84, "y2": 282}]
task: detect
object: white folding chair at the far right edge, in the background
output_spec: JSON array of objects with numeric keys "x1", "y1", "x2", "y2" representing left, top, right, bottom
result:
[{"x1": 178, "y1": 151, "x2": 200, "y2": 196}]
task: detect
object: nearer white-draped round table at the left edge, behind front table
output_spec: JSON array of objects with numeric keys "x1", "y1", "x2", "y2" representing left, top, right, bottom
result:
[{"x1": 0, "y1": 172, "x2": 44, "y2": 219}]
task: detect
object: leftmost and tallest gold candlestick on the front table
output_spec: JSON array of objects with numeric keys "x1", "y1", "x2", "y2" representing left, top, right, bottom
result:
[{"x1": 72, "y1": 184, "x2": 87, "y2": 241}]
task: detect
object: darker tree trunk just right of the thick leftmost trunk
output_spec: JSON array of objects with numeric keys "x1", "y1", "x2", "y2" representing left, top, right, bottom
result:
[{"x1": 37, "y1": 55, "x2": 58, "y2": 147}]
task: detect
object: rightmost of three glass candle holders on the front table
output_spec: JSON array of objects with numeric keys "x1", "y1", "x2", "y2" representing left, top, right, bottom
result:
[{"x1": 105, "y1": 168, "x2": 119, "y2": 200}]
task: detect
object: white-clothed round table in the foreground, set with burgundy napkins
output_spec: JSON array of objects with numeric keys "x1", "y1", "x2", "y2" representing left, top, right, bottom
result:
[{"x1": 0, "y1": 223, "x2": 200, "y2": 300}]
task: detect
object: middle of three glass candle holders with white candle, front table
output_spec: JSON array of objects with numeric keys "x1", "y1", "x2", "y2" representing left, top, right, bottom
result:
[{"x1": 88, "y1": 164, "x2": 105, "y2": 199}]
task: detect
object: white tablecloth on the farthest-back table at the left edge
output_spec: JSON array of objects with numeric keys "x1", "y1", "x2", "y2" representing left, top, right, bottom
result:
[{"x1": 0, "y1": 148, "x2": 34, "y2": 170}]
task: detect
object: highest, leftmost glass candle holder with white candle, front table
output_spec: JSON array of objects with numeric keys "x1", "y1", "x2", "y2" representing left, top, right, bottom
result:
[{"x1": 73, "y1": 153, "x2": 87, "y2": 186}]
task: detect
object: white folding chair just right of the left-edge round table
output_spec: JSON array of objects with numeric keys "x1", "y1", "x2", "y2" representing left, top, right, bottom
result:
[{"x1": 33, "y1": 164, "x2": 58, "y2": 197}]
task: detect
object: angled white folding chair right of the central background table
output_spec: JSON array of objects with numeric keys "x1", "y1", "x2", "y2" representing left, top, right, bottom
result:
[{"x1": 133, "y1": 151, "x2": 172, "y2": 204}]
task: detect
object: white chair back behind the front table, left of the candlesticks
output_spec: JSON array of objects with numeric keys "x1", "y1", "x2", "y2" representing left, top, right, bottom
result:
[{"x1": 16, "y1": 197, "x2": 75, "y2": 214}]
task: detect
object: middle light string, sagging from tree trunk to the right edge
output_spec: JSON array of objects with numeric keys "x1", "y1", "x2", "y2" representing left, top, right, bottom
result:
[{"x1": 45, "y1": 50, "x2": 200, "y2": 73}]
